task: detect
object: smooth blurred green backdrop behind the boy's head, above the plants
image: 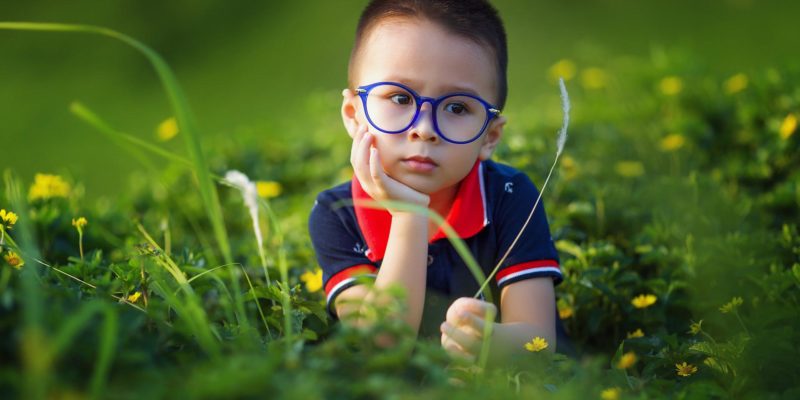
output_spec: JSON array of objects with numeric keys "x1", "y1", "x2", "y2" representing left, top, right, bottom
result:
[{"x1": 0, "y1": 0, "x2": 800, "y2": 197}]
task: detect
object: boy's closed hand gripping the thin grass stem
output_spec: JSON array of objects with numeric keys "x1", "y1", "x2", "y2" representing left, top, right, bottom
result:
[{"x1": 440, "y1": 297, "x2": 497, "y2": 362}]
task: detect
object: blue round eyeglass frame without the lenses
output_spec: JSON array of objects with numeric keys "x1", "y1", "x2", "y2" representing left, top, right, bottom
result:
[{"x1": 356, "y1": 81, "x2": 500, "y2": 144}]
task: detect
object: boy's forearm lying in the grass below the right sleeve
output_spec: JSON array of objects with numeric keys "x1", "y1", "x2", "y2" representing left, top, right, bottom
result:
[{"x1": 490, "y1": 322, "x2": 556, "y2": 363}]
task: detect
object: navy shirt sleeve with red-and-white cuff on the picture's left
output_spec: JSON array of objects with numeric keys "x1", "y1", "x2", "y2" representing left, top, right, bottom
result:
[{"x1": 308, "y1": 193, "x2": 378, "y2": 318}]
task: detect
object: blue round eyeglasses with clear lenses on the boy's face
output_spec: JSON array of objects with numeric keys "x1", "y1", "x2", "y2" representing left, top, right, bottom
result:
[{"x1": 356, "y1": 82, "x2": 500, "y2": 144}]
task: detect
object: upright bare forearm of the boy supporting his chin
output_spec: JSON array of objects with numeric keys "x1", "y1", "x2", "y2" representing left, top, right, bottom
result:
[{"x1": 365, "y1": 213, "x2": 428, "y2": 332}]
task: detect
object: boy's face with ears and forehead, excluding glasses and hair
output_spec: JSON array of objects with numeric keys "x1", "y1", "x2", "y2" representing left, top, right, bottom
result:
[{"x1": 342, "y1": 18, "x2": 505, "y2": 195}]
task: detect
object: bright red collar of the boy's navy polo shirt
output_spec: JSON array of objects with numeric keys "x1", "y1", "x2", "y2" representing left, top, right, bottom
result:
[{"x1": 351, "y1": 161, "x2": 489, "y2": 262}]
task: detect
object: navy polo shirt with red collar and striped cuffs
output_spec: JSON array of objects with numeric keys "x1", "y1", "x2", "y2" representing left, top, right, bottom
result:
[{"x1": 309, "y1": 160, "x2": 562, "y2": 336}]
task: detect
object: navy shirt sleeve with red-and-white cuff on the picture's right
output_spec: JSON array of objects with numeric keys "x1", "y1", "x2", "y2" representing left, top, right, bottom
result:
[{"x1": 495, "y1": 173, "x2": 563, "y2": 289}]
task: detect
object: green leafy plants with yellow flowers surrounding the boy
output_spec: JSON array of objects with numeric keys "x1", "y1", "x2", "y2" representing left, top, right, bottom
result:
[{"x1": 0, "y1": 50, "x2": 800, "y2": 399}]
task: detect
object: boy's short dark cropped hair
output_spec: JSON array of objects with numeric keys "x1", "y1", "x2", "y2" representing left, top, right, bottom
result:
[{"x1": 348, "y1": 0, "x2": 508, "y2": 110}]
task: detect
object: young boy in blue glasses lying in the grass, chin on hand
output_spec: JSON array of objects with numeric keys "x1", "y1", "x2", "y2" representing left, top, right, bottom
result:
[{"x1": 309, "y1": 0, "x2": 562, "y2": 359}]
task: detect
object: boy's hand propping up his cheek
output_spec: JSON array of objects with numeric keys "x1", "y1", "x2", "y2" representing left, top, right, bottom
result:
[{"x1": 350, "y1": 124, "x2": 430, "y2": 213}]
